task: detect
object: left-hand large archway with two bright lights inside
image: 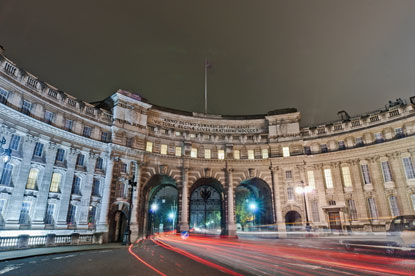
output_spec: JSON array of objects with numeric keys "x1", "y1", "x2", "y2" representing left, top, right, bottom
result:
[{"x1": 141, "y1": 175, "x2": 179, "y2": 236}]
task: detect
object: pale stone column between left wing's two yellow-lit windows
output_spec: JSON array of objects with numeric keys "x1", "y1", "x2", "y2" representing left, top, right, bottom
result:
[{"x1": 32, "y1": 142, "x2": 59, "y2": 229}]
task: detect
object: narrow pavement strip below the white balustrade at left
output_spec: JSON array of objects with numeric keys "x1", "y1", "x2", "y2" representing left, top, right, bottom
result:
[{"x1": 0, "y1": 243, "x2": 127, "y2": 262}]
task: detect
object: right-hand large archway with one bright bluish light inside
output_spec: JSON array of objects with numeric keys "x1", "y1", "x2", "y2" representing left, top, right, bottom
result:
[{"x1": 235, "y1": 177, "x2": 274, "y2": 231}]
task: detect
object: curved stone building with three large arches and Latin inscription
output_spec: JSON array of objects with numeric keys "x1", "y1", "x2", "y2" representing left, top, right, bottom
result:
[{"x1": 0, "y1": 48, "x2": 415, "y2": 241}]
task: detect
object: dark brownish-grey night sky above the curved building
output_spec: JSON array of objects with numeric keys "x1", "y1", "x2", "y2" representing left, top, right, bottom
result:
[{"x1": 0, "y1": 0, "x2": 415, "y2": 125}]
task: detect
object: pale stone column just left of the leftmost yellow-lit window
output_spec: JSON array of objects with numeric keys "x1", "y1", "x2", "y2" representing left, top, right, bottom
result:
[{"x1": 0, "y1": 135, "x2": 37, "y2": 229}]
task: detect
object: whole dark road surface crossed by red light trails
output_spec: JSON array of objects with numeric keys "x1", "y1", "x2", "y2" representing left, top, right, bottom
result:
[{"x1": 0, "y1": 235, "x2": 415, "y2": 276}]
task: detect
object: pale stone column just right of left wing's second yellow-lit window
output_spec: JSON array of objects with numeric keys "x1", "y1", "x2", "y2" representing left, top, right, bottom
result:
[{"x1": 56, "y1": 148, "x2": 79, "y2": 229}]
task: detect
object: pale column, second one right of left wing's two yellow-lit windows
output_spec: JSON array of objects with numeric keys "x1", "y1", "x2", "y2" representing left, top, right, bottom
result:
[{"x1": 77, "y1": 153, "x2": 97, "y2": 229}]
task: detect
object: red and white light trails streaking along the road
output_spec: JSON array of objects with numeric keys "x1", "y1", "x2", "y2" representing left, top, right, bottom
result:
[{"x1": 157, "y1": 235, "x2": 415, "y2": 275}]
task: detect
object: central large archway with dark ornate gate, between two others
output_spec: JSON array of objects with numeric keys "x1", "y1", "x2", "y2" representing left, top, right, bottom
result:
[{"x1": 190, "y1": 178, "x2": 225, "y2": 235}]
